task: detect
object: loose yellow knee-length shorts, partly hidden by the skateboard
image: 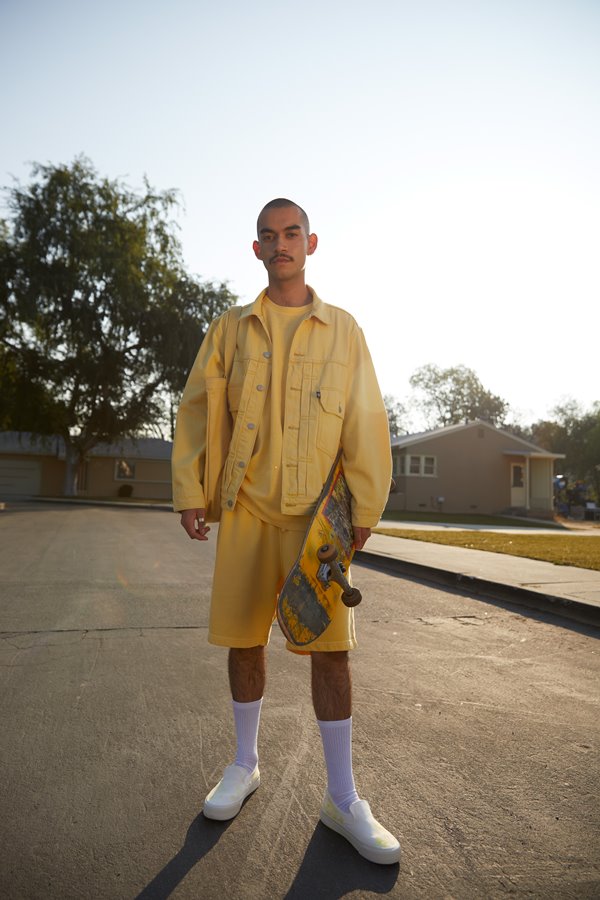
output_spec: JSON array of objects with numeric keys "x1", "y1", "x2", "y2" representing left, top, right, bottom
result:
[{"x1": 208, "y1": 503, "x2": 356, "y2": 653}]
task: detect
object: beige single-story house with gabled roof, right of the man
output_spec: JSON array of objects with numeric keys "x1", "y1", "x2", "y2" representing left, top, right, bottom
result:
[{"x1": 387, "y1": 420, "x2": 564, "y2": 518}]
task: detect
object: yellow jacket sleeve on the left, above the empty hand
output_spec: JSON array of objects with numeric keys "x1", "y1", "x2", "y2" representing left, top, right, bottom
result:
[{"x1": 171, "y1": 313, "x2": 228, "y2": 512}]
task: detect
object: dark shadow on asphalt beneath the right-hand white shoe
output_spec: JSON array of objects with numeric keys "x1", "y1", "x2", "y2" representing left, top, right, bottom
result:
[{"x1": 285, "y1": 822, "x2": 400, "y2": 900}]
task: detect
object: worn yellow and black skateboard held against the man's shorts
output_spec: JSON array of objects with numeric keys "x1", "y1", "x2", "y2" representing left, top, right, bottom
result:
[{"x1": 277, "y1": 450, "x2": 362, "y2": 647}]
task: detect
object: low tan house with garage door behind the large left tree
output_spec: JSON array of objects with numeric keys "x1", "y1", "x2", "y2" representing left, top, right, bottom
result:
[{"x1": 0, "y1": 431, "x2": 172, "y2": 501}]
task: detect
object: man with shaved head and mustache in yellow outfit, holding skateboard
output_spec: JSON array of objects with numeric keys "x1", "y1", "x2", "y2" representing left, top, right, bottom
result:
[{"x1": 173, "y1": 199, "x2": 400, "y2": 863}]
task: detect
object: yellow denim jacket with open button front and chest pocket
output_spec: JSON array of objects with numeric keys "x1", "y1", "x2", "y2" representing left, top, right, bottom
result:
[{"x1": 172, "y1": 289, "x2": 392, "y2": 528}]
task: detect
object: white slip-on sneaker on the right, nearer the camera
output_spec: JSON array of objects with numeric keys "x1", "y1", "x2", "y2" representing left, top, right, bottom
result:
[{"x1": 320, "y1": 792, "x2": 400, "y2": 865}]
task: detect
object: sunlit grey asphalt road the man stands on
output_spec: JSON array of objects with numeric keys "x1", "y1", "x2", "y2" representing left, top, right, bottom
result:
[{"x1": 0, "y1": 505, "x2": 600, "y2": 900}]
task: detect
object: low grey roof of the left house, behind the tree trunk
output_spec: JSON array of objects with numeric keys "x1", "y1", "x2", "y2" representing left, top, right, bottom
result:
[{"x1": 0, "y1": 431, "x2": 173, "y2": 459}]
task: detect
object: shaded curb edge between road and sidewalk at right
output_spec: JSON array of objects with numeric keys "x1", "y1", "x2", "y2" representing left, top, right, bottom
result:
[{"x1": 354, "y1": 550, "x2": 600, "y2": 628}]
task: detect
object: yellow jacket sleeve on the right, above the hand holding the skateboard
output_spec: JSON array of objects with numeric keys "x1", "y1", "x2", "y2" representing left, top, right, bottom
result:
[{"x1": 342, "y1": 328, "x2": 392, "y2": 528}]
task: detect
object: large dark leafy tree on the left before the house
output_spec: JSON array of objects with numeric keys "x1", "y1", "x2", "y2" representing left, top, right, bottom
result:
[{"x1": 0, "y1": 157, "x2": 235, "y2": 494}]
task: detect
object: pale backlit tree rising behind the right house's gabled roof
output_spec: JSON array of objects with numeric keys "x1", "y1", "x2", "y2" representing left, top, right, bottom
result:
[{"x1": 410, "y1": 364, "x2": 508, "y2": 428}]
